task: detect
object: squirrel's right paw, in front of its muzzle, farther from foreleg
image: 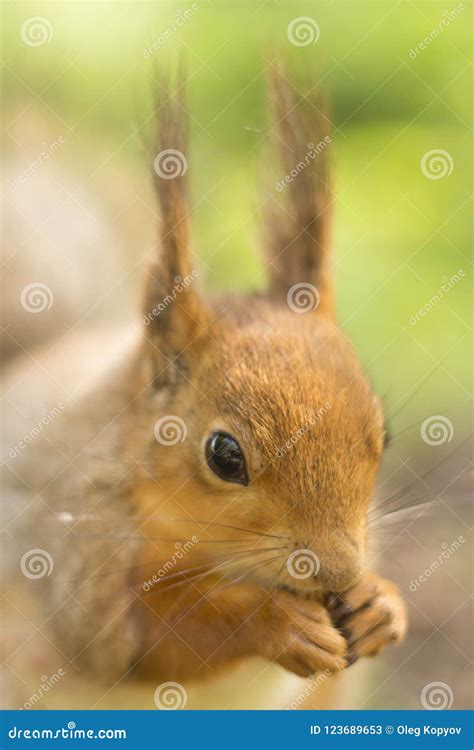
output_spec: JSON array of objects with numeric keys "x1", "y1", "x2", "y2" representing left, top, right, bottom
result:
[{"x1": 328, "y1": 573, "x2": 407, "y2": 664}]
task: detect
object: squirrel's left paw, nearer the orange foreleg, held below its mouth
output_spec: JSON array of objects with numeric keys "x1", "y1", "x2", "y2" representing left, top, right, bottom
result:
[{"x1": 263, "y1": 591, "x2": 347, "y2": 677}]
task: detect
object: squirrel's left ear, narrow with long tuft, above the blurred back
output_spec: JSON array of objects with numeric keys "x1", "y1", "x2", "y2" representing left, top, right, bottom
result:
[{"x1": 143, "y1": 66, "x2": 212, "y2": 380}]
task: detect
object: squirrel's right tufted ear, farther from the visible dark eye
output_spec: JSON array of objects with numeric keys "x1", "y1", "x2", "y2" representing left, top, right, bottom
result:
[{"x1": 264, "y1": 64, "x2": 333, "y2": 317}]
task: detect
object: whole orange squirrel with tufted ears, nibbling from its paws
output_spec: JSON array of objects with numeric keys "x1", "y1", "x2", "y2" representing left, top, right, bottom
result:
[{"x1": 0, "y1": 66, "x2": 407, "y2": 704}]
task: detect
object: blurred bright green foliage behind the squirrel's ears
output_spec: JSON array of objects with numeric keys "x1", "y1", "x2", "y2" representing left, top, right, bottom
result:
[{"x1": 3, "y1": 0, "x2": 472, "y2": 443}]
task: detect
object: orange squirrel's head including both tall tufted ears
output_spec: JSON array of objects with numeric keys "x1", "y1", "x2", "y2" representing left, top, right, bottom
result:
[{"x1": 138, "y1": 69, "x2": 384, "y2": 592}]
